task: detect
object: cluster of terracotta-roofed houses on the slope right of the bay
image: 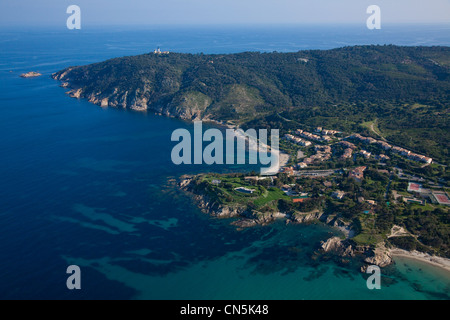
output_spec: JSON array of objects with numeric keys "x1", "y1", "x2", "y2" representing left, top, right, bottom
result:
[{"x1": 281, "y1": 127, "x2": 444, "y2": 209}]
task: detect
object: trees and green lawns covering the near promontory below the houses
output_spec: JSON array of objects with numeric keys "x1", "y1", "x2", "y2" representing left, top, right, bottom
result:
[{"x1": 188, "y1": 166, "x2": 450, "y2": 257}]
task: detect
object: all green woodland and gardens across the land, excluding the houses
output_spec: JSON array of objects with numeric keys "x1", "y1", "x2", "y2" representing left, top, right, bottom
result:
[{"x1": 54, "y1": 45, "x2": 450, "y2": 257}]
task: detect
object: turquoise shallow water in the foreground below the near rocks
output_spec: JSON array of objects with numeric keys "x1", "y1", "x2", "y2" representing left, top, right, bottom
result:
[{"x1": 64, "y1": 220, "x2": 450, "y2": 300}]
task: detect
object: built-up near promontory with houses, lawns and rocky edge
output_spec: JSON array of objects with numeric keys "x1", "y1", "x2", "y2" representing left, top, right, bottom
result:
[{"x1": 182, "y1": 124, "x2": 450, "y2": 255}]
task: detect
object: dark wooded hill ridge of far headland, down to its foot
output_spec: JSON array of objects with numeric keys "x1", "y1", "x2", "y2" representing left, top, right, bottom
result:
[{"x1": 52, "y1": 46, "x2": 450, "y2": 129}]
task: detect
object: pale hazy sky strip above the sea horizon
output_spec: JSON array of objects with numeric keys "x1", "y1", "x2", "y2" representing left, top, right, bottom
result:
[{"x1": 0, "y1": 0, "x2": 450, "y2": 26}]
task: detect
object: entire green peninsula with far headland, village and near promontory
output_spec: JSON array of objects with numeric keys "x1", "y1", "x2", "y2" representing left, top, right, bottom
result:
[{"x1": 52, "y1": 45, "x2": 450, "y2": 268}]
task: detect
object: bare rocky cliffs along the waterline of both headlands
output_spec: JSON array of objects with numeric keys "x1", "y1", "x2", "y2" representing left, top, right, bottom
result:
[{"x1": 52, "y1": 57, "x2": 448, "y2": 272}]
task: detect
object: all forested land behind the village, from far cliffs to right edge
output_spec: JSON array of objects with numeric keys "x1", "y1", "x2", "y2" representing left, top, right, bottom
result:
[{"x1": 54, "y1": 45, "x2": 450, "y2": 164}]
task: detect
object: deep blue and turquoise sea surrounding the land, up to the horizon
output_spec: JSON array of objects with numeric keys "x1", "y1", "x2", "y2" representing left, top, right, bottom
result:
[{"x1": 0, "y1": 25, "x2": 450, "y2": 300}]
